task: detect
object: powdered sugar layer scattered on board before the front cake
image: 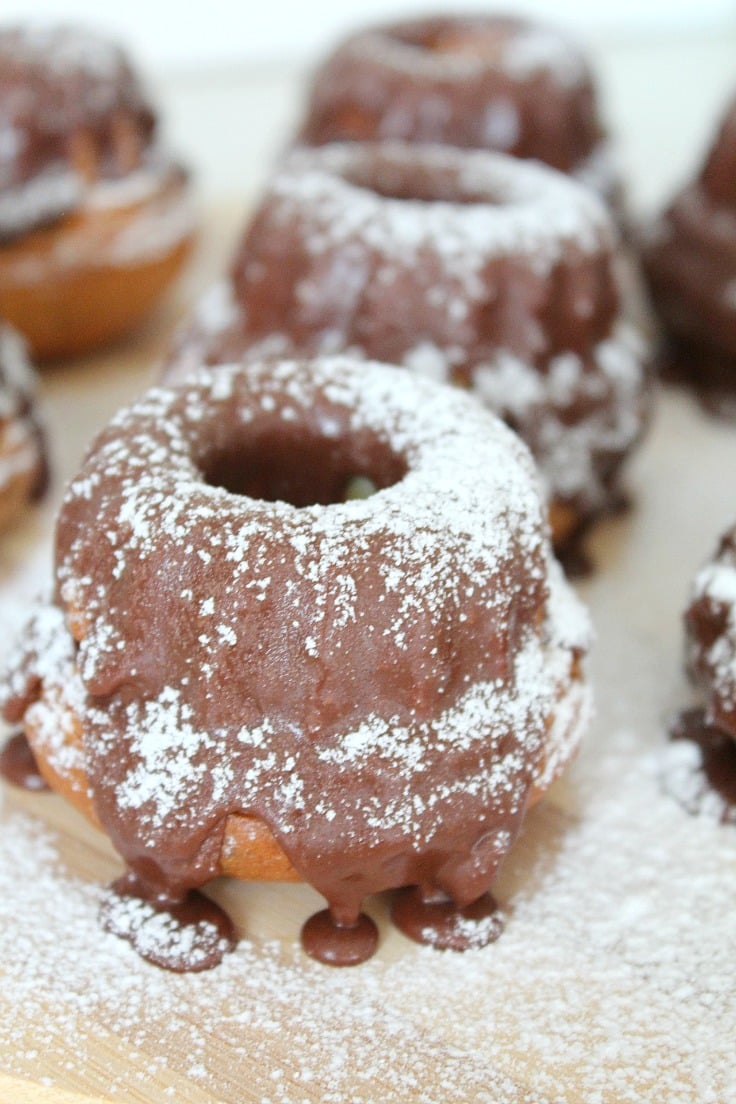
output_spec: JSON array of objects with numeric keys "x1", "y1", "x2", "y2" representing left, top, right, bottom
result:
[{"x1": 0, "y1": 731, "x2": 736, "y2": 1104}]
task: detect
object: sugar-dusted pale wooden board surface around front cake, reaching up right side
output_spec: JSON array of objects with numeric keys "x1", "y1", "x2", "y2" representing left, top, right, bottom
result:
[{"x1": 0, "y1": 364, "x2": 736, "y2": 1104}]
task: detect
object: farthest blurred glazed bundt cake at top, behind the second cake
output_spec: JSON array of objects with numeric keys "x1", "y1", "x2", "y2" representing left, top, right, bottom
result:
[{"x1": 298, "y1": 14, "x2": 621, "y2": 206}]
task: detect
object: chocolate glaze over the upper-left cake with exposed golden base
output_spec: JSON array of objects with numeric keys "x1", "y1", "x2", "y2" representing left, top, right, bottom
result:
[{"x1": 0, "y1": 25, "x2": 156, "y2": 244}]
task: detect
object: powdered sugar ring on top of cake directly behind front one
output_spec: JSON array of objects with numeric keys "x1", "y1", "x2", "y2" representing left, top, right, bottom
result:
[{"x1": 271, "y1": 142, "x2": 612, "y2": 284}]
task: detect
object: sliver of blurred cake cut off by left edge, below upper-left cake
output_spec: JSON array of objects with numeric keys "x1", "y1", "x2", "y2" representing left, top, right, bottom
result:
[{"x1": 0, "y1": 322, "x2": 49, "y2": 529}]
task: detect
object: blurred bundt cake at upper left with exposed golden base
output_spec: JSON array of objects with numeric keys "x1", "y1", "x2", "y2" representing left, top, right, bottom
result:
[{"x1": 0, "y1": 26, "x2": 194, "y2": 357}]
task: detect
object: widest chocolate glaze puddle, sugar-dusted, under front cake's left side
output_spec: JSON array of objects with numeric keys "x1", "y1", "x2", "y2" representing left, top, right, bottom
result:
[{"x1": 100, "y1": 873, "x2": 236, "y2": 974}]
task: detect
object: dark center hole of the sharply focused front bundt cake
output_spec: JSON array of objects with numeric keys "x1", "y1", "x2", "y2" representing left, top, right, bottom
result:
[{"x1": 203, "y1": 431, "x2": 406, "y2": 508}]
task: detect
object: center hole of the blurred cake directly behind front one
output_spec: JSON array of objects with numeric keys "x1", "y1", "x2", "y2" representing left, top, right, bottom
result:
[{"x1": 342, "y1": 157, "x2": 494, "y2": 206}]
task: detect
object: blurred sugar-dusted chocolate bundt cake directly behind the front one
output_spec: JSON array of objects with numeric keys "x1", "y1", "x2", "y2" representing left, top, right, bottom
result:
[{"x1": 164, "y1": 142, "x2": 650, "y2": 560}]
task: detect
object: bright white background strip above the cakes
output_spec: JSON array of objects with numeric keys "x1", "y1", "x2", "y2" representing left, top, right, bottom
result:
[{"x1": 0, "y1": 0, "x2": 736, "y2": 72}]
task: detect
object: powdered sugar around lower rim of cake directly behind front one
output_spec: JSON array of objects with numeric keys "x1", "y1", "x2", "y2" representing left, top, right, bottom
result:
[{"x1": 164, "y1": 283, "x2": 650, "y2": 511}]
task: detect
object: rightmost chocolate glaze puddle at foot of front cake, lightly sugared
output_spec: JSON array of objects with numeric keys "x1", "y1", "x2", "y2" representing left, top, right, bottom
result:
[{"x1": 391, "y1": 885, "x2": 504, "y2": 951}]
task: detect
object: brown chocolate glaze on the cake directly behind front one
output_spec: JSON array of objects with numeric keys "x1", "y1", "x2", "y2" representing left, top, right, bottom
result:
[{"x1": 231, "y1": 150, "x2": 620, "y2": 357}]
